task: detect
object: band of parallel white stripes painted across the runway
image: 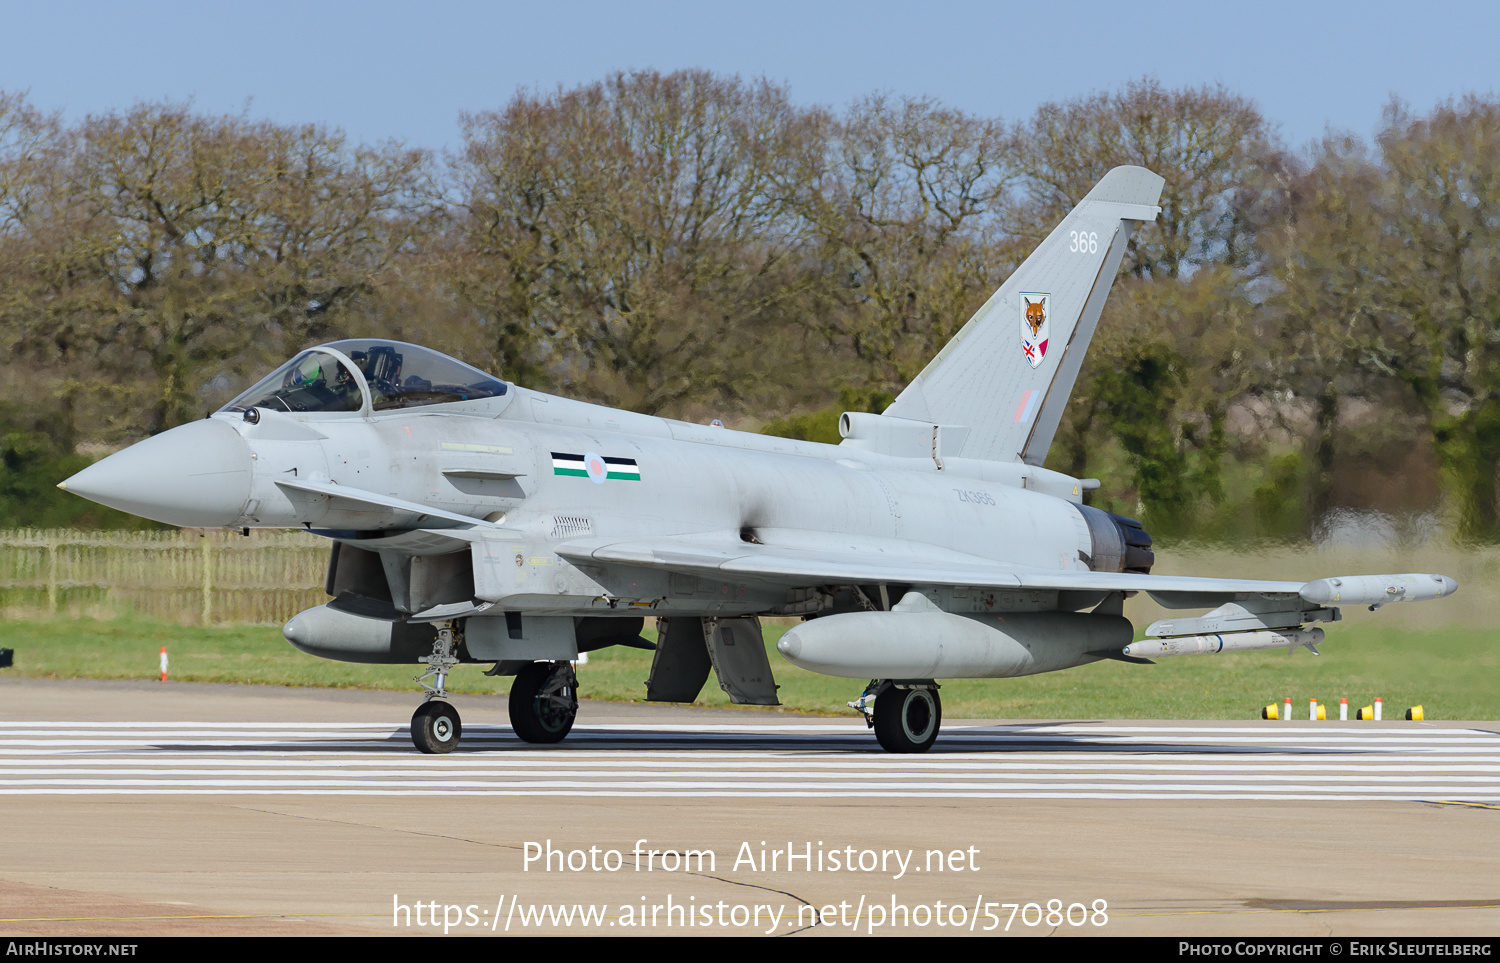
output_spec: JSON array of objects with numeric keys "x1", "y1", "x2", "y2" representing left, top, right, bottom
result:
[{"x1": 0, "y1": 722, "x2": 1500, "y2": 803}]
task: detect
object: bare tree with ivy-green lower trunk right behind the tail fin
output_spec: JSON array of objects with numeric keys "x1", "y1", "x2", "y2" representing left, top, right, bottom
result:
[{"x1": 1016, "y1": 78, "x2": 1286, "y2": 525}]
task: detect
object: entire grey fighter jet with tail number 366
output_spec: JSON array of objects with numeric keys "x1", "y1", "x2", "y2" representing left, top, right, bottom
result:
[{"x1": 63, "y1": 167, "x2": 1457, "y2": 753}]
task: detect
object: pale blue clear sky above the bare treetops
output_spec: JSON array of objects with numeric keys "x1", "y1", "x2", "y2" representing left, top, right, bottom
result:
[{"x1": 0, "y1": 0, "x2": 1500, "y2": 149}]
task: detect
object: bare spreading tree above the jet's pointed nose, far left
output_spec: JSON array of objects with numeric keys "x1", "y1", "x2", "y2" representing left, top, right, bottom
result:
[{"x1": 18, "y1": 104, "x2": 425, "y2": 432}]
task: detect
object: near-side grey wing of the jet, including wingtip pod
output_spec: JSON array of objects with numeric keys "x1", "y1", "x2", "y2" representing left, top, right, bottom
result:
[{"x1": 557, "y1": 533, "x2": 1457, "y2": 608}]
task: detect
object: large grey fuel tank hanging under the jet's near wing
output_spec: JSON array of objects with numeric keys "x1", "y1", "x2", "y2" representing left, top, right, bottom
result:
[{"x1": 776, "y1": 593, "x2": 1131, "y2": 680}]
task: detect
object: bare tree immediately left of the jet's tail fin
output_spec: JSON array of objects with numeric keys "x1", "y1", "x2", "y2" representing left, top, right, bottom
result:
[{"x1": 804, "y1": 95, "x2": 1019, "y2": 390}]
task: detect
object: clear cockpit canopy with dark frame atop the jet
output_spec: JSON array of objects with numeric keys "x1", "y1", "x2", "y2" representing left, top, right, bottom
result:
[{"x1": 224, "y1": 338, "x2": 506, "y2": 413}]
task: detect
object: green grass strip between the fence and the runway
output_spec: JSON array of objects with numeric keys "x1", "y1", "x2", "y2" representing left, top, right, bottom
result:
[{"x1": 0, "y1": 618, "x2": 1500, "y2": 720}]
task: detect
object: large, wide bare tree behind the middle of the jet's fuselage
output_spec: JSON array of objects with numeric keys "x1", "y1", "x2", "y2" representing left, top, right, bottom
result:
[{"x1": 453, "y1": 71, "x2": 834, "y2": 413}]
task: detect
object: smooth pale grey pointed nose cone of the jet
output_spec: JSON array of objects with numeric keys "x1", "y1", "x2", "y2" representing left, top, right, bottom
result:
[{"x1": 59, "y1": 419, "x2": 251, "y2": 528}]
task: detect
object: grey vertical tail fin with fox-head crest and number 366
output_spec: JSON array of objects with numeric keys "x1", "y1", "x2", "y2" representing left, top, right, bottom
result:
[{"x1": 885, "y1": 167, "x2": 1166, "y2": 465}]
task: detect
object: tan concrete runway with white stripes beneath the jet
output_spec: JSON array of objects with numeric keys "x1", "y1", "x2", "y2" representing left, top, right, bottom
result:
[{"x1": 0, "y1": 680, "x2": 1500, "y2": 938}]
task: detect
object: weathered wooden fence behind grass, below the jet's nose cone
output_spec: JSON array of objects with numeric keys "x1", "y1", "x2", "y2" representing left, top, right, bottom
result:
[{"x1": 0, "y1": 528, "x2": 329, "y2": 626}]
